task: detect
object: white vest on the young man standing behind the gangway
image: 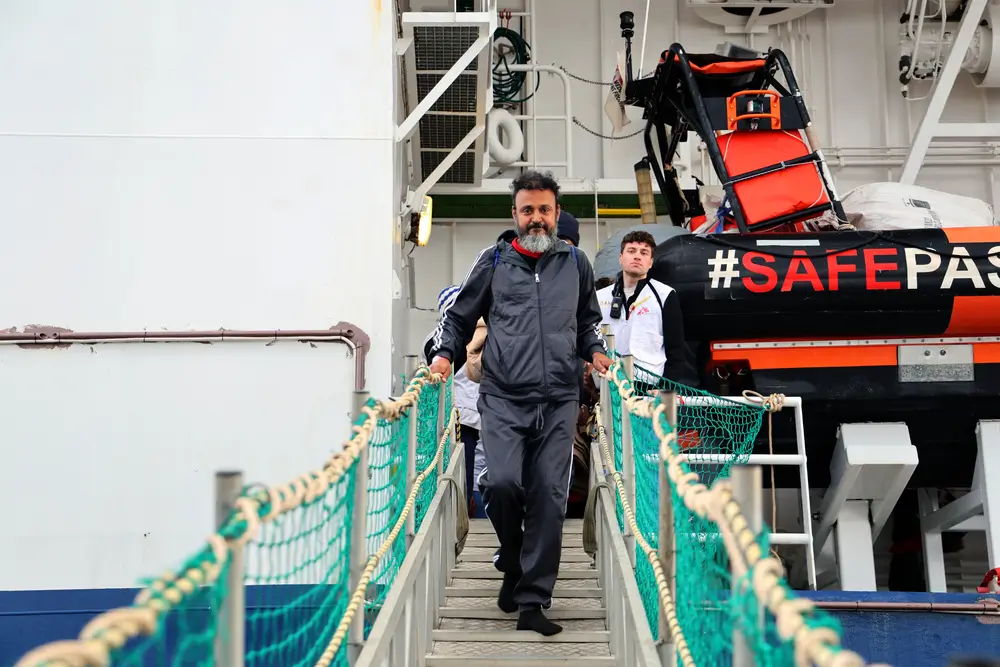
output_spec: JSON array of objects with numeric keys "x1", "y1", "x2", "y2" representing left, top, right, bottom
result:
[{"x1": 597, "y1": 280, "x2": 674, "y2": 375}]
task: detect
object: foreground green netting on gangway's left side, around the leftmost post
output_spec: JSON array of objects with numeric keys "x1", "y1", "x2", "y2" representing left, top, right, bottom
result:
[{"x1": 88, "y1": 464, "x2": 356, "y2": 667}]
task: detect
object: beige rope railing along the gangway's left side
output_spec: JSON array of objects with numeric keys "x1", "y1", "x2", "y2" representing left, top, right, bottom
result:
[{"x1": 15, "y1": 366, "x2": 458, "y2": 667}]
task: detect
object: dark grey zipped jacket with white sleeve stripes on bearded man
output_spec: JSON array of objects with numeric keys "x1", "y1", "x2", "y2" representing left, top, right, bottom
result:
[{"x1": 428, "y1": 241, "x2": 607, "y2": 402}]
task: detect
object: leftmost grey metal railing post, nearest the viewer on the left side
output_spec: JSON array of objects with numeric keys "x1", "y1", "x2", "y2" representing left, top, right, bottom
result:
[{"x1": 215, "y1": 470, "x2": 246, "y2": 667}]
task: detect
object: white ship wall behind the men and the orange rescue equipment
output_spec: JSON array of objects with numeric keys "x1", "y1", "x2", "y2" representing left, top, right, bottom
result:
[{"x1": 409, "y1": 0, "x2": 1000, "y2": 350}]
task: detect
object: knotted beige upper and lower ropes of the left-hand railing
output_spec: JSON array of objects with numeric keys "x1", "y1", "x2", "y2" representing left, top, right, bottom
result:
[{"x1": 14, "y1": 366, "x2": 457, "y2": 667}]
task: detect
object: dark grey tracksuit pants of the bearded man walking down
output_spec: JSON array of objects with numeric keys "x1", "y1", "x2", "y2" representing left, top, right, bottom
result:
[{"x1": 478, "y1": 394, "x2": 579, "y2": 609}]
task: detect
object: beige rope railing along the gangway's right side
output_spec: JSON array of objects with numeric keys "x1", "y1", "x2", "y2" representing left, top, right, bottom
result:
[{"x1": 597, "y1": 360, "x2": 885, "y2": 667}]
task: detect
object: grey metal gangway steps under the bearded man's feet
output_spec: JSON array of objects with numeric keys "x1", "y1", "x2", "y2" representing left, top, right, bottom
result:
[{"x1": 432, "y1": 519, "x2": 616, "y2": 667}]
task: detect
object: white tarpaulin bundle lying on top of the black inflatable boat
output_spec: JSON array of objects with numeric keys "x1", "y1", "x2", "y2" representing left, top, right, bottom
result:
[{"x1": 842, "y1": 183, "x2": 998, "y2": 231}]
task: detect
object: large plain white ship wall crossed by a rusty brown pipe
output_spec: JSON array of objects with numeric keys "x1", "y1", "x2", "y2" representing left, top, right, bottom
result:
[{"x1": 0, "y1": 0, "x2": 405, "y2": 591}]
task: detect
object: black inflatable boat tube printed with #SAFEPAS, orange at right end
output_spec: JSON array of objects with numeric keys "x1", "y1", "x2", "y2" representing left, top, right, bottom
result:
[{"x1": 650, "y1": 227, "x2": 1000, "y2": 342}]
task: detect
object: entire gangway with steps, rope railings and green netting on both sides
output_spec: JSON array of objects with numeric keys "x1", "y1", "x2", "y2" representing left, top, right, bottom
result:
[{"x1": 17, "y1": 360, "x2": 866, "y2": 667}]
